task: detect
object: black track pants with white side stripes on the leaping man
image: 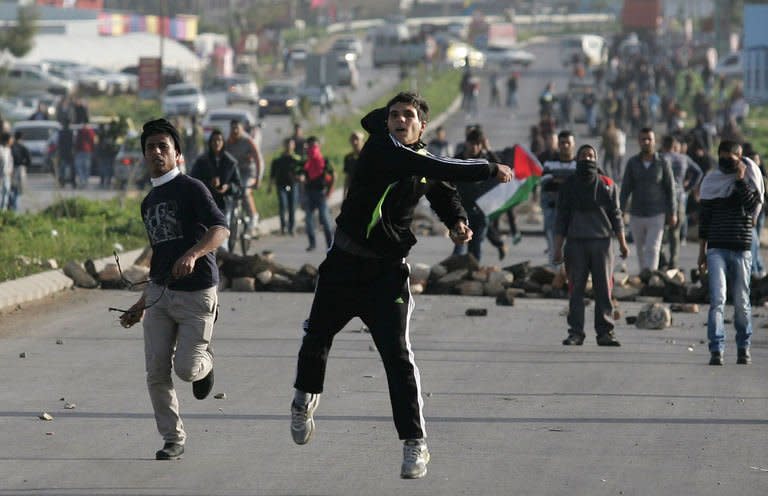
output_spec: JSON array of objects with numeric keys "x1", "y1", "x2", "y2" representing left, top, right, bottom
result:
[{"x1": 294, "y1": 247, "x2": 426, "y2": 439}]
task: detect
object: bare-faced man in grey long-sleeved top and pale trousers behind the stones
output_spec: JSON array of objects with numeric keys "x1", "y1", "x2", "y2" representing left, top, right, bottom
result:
[{"x1": 619, "y1": 127, "x2": 677, "y2": 273}]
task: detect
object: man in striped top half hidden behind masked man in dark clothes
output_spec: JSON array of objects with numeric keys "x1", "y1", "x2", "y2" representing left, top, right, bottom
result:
[{"x1": 540, "y1": 131, "x2": 576, "y2": 263}]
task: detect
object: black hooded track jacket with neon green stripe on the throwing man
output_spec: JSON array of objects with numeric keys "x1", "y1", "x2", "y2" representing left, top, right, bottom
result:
[{"x1": 336, "y1": 108, "x2": 498, "y2": 258}]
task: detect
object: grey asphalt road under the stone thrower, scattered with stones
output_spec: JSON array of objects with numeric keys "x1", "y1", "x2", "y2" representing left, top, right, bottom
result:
[{"x1": 0, "y1": 38, "x2": 768, "y2": 495}]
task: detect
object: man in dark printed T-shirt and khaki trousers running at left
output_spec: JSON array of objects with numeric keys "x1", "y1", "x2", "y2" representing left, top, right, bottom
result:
[{"x1": 120, "y1": 119, "x2": 229, "y2": 460}]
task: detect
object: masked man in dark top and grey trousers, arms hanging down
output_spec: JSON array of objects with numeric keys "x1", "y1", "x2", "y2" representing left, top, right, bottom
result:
[{"x1": 554, "y1": 145, "x2": 629, "y2": 346}]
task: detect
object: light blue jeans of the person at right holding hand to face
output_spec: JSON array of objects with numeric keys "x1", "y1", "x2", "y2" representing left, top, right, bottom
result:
[{"x1": 707, "y1": 248, "x2": 752, "y2": 353}]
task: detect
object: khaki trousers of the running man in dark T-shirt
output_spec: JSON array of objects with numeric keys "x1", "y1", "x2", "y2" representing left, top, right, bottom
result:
[{"x1": 144, "y1": 284, "x2": 218, "y2": 444}]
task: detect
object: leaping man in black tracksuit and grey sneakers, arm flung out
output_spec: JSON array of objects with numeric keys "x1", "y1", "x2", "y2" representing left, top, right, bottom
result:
[{"x1": 291, "y1": 93, "x2": 512, "y2": 478}]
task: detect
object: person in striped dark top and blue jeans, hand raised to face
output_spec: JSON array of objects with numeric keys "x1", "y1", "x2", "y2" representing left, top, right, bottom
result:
[{"x1": 699, "y1": 140, "x2": 765, "y2": 365}]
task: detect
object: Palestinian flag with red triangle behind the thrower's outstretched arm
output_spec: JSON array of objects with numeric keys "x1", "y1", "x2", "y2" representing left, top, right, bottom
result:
[{"x1": 476, "y1": 145, "x2": 542, "y2": 219}]
